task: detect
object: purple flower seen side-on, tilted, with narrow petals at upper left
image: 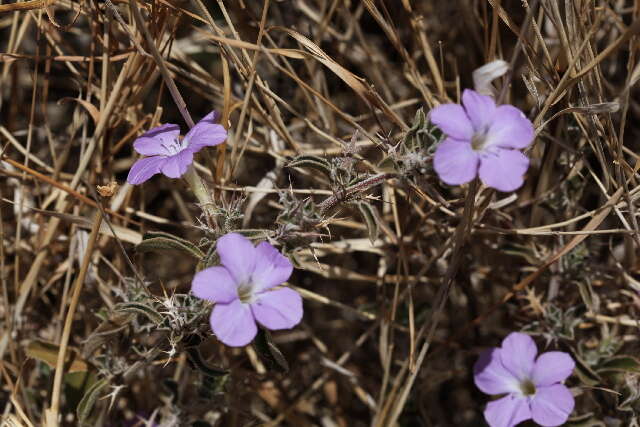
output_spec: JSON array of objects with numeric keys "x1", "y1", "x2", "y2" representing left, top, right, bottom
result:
[{"x1": 127, "y1": 111, "x2": 227, "y2": 184}]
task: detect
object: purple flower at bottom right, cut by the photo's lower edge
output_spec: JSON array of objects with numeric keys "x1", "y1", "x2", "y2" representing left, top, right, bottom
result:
[{"x1": 473, "y1": 332, "x2": 575, "y2": 427}]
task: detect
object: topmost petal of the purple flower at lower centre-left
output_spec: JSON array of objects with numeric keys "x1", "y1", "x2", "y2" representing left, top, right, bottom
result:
[{"x1": 216, "y1": 233, "x2": 257, "y2": 284}]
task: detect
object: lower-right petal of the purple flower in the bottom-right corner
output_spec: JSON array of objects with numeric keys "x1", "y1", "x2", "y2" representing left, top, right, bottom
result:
[{"x1": 531, "y1": 384, "x2": 575, "y2": 427}]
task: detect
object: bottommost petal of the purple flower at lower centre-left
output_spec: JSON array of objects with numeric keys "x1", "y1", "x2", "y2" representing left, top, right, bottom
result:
[{"x1": 209, "y1": 299, "x2": 258, "y2": 347}]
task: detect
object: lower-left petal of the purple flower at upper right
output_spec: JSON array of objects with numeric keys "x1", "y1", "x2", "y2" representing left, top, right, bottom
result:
[{"x1": 433, "y1": 138, "x2": 480, "y2": 185}]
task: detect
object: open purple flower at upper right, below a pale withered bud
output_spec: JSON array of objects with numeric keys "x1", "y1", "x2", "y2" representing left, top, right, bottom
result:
[{"x1": 430, "y1": 89, "x2": 534, "y2": 191}]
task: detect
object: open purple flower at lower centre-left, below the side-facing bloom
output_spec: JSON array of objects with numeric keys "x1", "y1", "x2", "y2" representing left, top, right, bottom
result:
[{"x1": 191, "y1": 233, "x2": 302, "y2": 347}]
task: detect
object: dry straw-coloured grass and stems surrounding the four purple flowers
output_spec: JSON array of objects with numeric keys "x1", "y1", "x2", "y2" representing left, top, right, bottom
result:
[{"x1": 0, "y1": 0, "x2": 640, "y2": 427}]
